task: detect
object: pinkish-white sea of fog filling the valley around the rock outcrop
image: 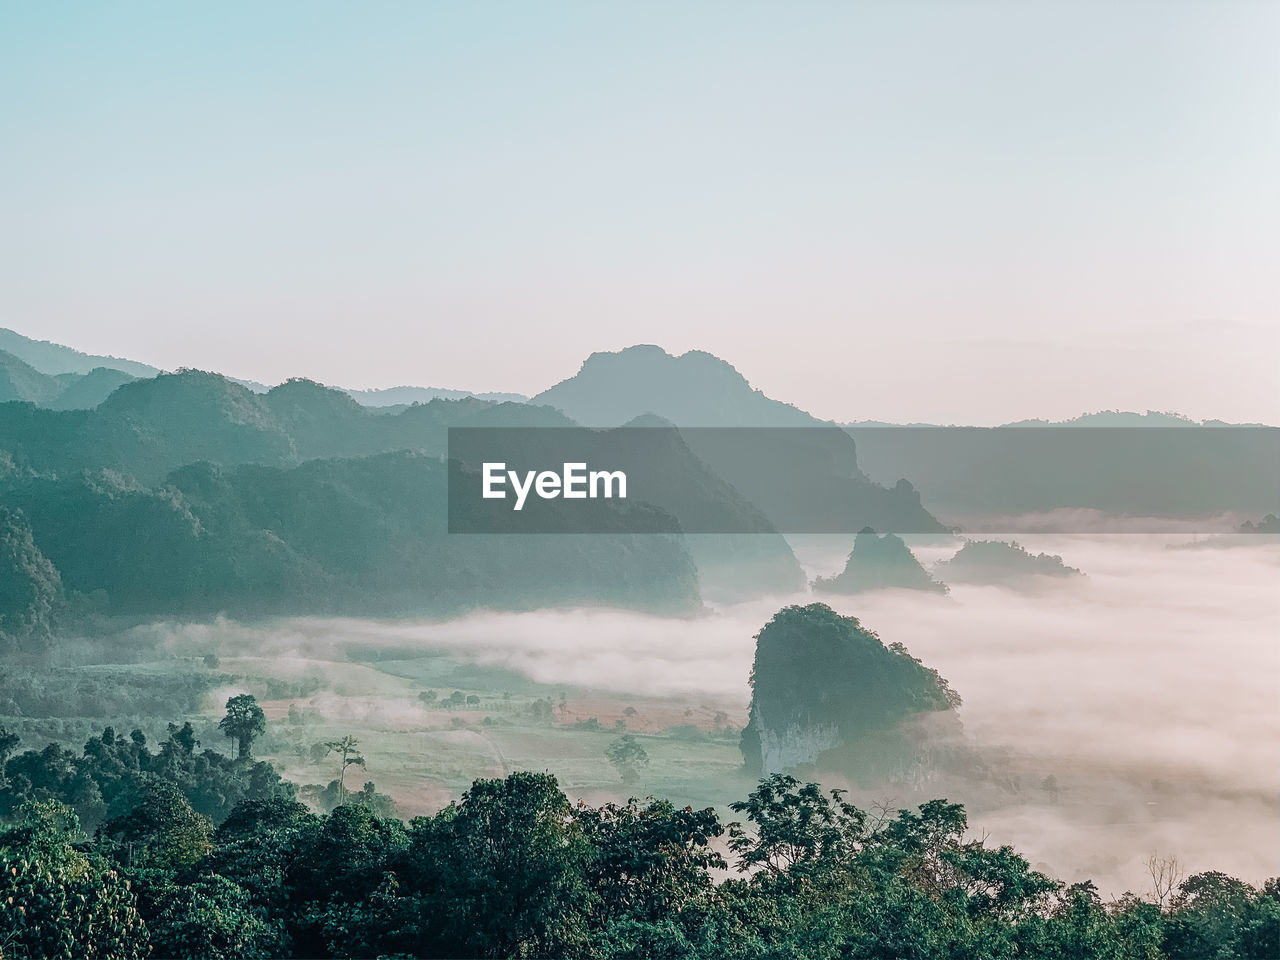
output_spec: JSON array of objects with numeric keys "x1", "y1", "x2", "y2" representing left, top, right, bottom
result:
[{"x1": 135, "y1": 535, "x2": 1280, "y2": 895}]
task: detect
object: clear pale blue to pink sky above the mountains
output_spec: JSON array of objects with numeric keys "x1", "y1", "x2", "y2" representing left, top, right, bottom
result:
[{"x1": 0, "y1": 0, "x2": 1280, "y2": 424}]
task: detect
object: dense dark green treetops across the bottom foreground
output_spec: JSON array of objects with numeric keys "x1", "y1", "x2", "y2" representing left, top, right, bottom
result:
[{"x1": 0, "y1": 773, "x2": 1280, "y2": 960}]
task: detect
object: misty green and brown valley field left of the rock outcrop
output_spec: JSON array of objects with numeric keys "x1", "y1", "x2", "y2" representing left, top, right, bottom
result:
[{"x1": 0, "y1": 649, "x2": 751, "y2": 817}]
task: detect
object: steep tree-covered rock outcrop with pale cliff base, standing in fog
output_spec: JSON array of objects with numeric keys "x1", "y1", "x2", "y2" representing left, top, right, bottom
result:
[{"x1": 741, "y1": 603, "x2": 960, "y2": 776}]
